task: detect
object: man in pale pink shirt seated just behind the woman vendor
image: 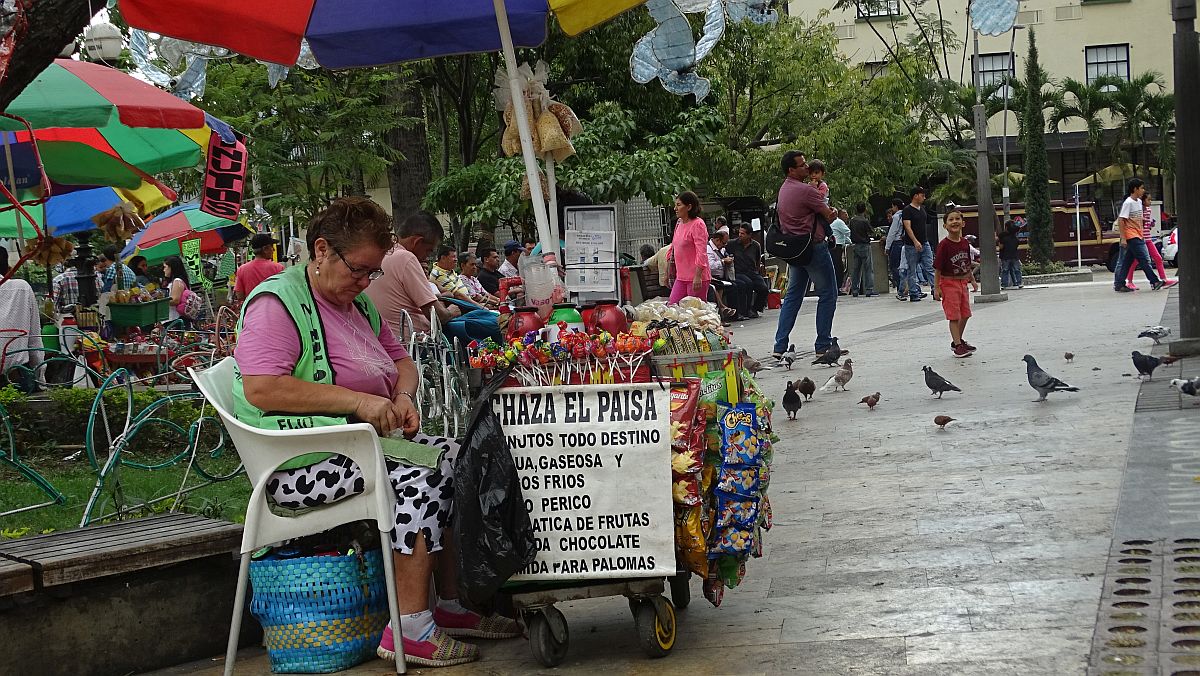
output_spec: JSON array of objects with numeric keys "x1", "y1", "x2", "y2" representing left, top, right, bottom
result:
[{"x1": 365, "y1": 211, "x2": 458, "y2": 340}]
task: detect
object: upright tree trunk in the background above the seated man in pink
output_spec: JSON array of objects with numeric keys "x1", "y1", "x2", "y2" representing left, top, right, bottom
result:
[{"x1": 385, "y1": 66, "x2": 430, "y2": 226}]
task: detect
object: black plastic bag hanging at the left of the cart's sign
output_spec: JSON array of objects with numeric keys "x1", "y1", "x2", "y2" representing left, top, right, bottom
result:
[{"x1": 454, "y1": 373, "x2": 538, "y2": 610}]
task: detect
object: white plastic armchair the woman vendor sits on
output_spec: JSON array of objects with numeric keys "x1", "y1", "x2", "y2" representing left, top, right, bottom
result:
[{"x1": 188, "y1": 357, "x2": 407, "y2": 676}]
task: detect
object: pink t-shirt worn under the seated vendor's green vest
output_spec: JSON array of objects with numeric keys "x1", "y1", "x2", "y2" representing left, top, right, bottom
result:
[{"x1": 233, "y1": 293, "x2": 408, "y2": 397}]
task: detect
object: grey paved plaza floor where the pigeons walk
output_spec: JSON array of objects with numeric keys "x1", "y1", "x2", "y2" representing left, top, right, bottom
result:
[{"x1": 159, "y1": 277, "x2": 1200, "y2": 676}]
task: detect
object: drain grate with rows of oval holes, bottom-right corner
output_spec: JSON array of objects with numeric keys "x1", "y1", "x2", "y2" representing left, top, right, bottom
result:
[{"x1": 1090, "y1": 538, "x2": 1200, "y2": 675}]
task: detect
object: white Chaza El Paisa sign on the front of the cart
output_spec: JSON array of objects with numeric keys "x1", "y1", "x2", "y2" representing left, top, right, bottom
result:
[{"x1": 492, "y1": 383, "x2": 676, "y2": 581}]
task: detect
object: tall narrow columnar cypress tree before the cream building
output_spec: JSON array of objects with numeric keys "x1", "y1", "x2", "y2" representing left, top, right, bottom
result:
[{"x1": 1022, "y1": 30, "x2": 1054, "y2": 263}]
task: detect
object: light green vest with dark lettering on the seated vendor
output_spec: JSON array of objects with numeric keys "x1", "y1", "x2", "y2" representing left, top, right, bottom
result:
[{"x1": 233, "y1": 265, "x2": 383, "y2": 469}]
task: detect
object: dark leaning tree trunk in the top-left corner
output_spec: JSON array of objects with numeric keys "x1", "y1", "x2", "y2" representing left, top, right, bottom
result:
[{"x1": 0, "y1": 0, "x2": 104, "y2": 109}]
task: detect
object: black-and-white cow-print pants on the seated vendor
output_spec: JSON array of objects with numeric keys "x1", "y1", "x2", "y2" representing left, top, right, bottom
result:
[{"x1": 266, "y1": 433, "x2": 458, "y2": 554}]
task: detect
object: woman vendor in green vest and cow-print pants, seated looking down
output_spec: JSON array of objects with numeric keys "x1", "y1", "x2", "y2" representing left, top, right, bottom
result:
[{"x1": 234, "y1": 197, "x2": 521, "y2": 666}]
